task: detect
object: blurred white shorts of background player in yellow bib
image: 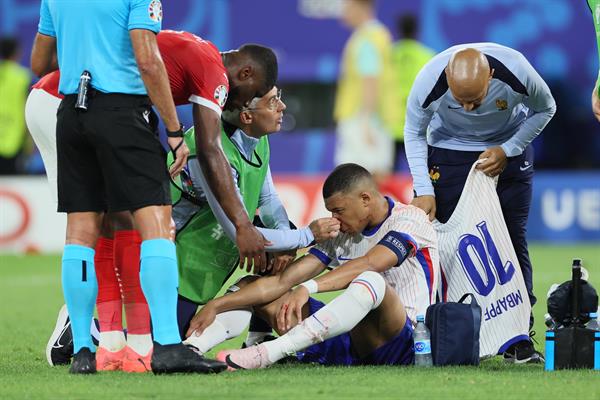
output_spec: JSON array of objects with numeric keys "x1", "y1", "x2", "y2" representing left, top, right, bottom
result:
[{"x1": 335, "y1": 117, "x2": 394, "y2": 173}]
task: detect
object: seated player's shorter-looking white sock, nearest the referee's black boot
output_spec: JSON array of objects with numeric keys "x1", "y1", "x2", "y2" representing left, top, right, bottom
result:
[{"x1": 183, "y1": 310, "x2": 252, "y2": 354}]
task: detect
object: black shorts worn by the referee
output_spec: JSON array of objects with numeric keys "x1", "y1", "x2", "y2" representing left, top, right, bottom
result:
[{"x1": 56, "y1": 92, "x2": 171, "y2": 213}]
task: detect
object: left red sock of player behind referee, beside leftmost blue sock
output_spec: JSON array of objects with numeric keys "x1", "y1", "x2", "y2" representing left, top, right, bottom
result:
[{"x1": 94, "y1": 237, "x2": 123, "y2": 332}]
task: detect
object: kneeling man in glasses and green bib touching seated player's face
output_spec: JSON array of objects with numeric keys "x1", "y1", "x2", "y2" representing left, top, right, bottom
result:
[{"x1": 172, "y1": 87, "x2": 340, "y2": 337}]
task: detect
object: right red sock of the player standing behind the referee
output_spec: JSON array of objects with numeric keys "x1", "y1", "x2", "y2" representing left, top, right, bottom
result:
[{"x1": 115, "y1": 231, "x2": 150, "y2": 335}]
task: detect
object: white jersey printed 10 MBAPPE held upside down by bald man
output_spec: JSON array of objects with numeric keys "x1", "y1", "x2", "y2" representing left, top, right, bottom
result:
[{"x1": 434, "y1": 163, "x2": 531, "y2": 357}]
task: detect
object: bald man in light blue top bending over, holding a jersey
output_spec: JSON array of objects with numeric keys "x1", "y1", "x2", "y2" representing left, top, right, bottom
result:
[{"x1": 404, "y1": 43, "x2": 556, "y2": 362}]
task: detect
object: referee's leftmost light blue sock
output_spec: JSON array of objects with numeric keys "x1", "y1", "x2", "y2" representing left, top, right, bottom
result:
[{"x1": 62, "y1": 244, "x2": 98, "y2": 353}]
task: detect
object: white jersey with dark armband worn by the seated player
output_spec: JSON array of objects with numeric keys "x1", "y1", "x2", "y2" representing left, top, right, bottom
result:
[{"x1": 310, "y1": 198, "x2": 440, "y2": 324}]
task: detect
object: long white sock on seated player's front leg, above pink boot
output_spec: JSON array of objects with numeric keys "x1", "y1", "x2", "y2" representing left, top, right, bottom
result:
[{"x1": 262, "y1": 271, "x2": 385, "y2": 363}]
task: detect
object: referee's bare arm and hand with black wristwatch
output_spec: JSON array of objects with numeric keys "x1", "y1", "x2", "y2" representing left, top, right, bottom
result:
[{"x1": 129, "y1": 29, "x2": 190, "y2": 176}]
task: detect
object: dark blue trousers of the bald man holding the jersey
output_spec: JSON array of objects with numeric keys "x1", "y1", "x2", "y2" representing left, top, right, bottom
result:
[{"x1": 428, "y1": 146, "x2": 537, "y2": 306}]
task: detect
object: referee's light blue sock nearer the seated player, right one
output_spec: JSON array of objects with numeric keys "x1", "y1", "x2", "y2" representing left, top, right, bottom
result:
[{"x1": 140, "y1": 239, "x2": 181, "y2": 344}]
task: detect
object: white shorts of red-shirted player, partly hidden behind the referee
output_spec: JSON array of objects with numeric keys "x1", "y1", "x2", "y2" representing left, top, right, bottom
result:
[{"x1": 25, "y1": 89, "x2": 61, "y2": 204}]
